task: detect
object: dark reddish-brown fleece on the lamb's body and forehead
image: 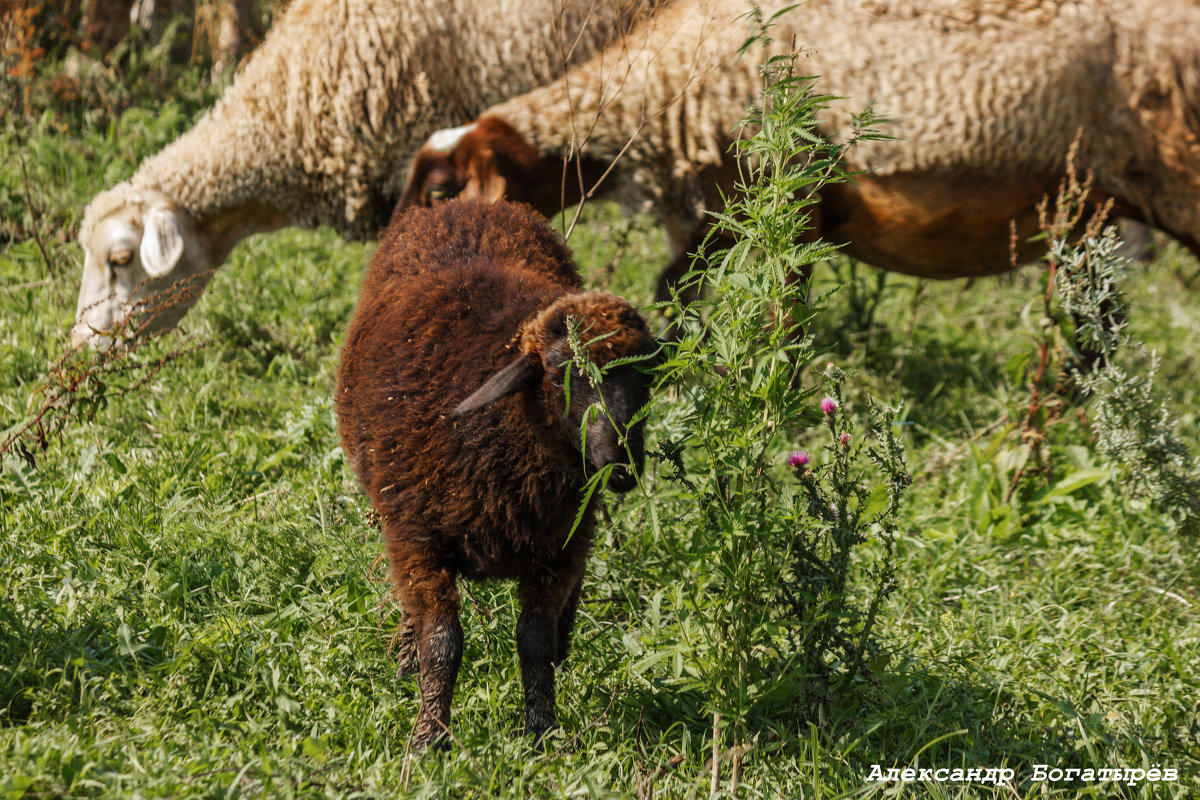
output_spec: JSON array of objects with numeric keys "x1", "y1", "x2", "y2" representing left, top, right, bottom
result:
[{"x1": 337, "y1": 200, "x2": 653, "y2": 522}]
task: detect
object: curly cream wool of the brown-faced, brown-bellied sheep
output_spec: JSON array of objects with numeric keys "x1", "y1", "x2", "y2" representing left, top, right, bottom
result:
[{"x1": 484, "y1": 0, "x2": 1200, "y2": 269}]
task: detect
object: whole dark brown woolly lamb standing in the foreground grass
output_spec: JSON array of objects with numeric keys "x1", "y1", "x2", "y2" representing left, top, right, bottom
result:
[{"x1": 337, "y1": 200, "x2": 653, "y2": 747}]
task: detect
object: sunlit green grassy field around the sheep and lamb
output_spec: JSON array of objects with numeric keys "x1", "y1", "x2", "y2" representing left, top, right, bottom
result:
[{"x1": 0, "y1": 29, "x2": 1200, "y2": 799}]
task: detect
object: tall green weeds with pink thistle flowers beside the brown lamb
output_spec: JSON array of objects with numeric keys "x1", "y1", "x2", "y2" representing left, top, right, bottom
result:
[{"x1": 648, "y1": 32, "x2": 910, "y2": 792}]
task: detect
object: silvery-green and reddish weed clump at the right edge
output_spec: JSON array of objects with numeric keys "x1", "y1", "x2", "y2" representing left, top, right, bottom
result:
[{"x1": 1014, "y1": 146, "x2": 1200, "y2": 534}]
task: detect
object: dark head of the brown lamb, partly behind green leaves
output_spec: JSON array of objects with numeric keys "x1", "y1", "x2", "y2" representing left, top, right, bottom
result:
[{"x1": 455, "y1": 293, "x2": 658, "y2": 492}]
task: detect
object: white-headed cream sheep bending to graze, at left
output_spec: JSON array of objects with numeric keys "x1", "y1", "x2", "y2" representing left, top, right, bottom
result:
[{"x1": 72, "y1": 0, "x2": 655, "y2": 345}]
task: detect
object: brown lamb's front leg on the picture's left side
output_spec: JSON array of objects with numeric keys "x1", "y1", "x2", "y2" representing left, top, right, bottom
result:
[{"x1": 397, "y1": 567, "x2": 462, "y2": 750}]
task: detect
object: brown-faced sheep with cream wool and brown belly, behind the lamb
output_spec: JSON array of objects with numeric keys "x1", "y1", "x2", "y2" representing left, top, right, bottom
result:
[{"x1": 402, "y1": 0, "x2": 1200, "y2": 278}]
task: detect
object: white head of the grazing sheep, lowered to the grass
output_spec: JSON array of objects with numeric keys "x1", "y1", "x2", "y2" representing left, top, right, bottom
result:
[{"x1": 71, "y1": 184, "x2": 211, "y2": 348}]
